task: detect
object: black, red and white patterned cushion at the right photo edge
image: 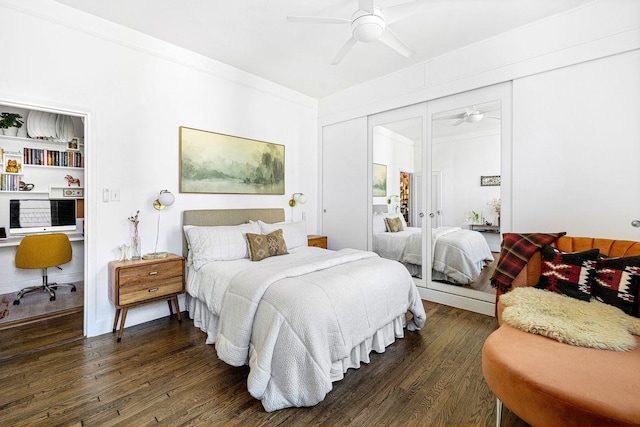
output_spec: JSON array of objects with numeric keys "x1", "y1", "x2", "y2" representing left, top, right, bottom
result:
[{"x1": 591, "y1": 255, "x2": 640, "y2": 317}]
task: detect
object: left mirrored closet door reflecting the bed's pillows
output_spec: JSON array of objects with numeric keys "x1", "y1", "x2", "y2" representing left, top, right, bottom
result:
[{"x1": 368, "y1": 103, "x2": 431, "y2": 287}]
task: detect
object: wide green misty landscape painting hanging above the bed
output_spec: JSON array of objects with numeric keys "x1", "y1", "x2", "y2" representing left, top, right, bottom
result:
[{"x1": 180, "y1": 126, "x2": 285, "y2": 194}]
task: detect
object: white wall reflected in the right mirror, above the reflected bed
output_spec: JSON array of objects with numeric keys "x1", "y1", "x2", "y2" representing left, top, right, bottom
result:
[{"x1": 431, "y1": 135, "x2": 500, "y2": 228}]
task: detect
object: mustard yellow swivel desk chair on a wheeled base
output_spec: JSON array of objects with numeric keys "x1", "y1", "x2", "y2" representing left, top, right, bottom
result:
[{"x1": 13, "y1": 233, "x2": 76, "y2": 305}]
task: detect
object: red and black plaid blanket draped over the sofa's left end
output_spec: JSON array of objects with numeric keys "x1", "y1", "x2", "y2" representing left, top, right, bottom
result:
[{"x1": 491, "y1": 231, "x2": 567, "y2": 292}]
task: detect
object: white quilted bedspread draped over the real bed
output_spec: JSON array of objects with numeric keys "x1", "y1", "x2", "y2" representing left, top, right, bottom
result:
[{"x1": 188, "y1": 247, "x2": 426, "y2": 411}]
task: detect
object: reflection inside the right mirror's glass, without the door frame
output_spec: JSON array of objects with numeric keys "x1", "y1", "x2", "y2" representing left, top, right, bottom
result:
[{"x1": 431, "y1": 101, "x2": 501, "y2": 294}]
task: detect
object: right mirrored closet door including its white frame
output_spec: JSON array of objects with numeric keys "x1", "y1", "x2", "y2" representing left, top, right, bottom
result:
[{"x1": 423, "y1": 83, "x2": 511, "y2": 314}]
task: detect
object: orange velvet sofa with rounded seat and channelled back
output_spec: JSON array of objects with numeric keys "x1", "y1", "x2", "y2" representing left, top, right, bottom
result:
[{"x1": 482, "y1": 236, "x2": 640, "y2": 426}]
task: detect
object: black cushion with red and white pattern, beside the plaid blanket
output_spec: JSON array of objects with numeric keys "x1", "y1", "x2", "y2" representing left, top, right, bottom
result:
[{"x1": 535, "y1": 245, "x2": 600, "y2": 301}]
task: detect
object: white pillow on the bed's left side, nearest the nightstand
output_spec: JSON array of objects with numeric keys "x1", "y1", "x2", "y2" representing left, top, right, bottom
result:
[{"x1": 183, "y1": 223, "x2": 260, "y2": 270}]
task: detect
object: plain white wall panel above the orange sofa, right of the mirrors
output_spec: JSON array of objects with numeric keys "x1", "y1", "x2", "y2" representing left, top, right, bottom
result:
[{"x1": 512, "y1": 50, "x2": 640, "y2": 240}]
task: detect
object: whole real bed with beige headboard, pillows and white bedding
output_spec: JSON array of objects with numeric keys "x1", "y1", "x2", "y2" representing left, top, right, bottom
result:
[{"x1": 183, "y1": 209, "x2": 426, "y2": 411}]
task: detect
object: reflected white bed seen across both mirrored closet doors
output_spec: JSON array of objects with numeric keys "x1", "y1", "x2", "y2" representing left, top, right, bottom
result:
[{"x1": 373, "y1": 212, "x2": 494, "y2": 285}]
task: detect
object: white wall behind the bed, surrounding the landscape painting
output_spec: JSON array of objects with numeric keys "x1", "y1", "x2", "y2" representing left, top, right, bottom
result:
[{"x1": 0, "y1": 0, "x2": 318, "y2": 335}]
